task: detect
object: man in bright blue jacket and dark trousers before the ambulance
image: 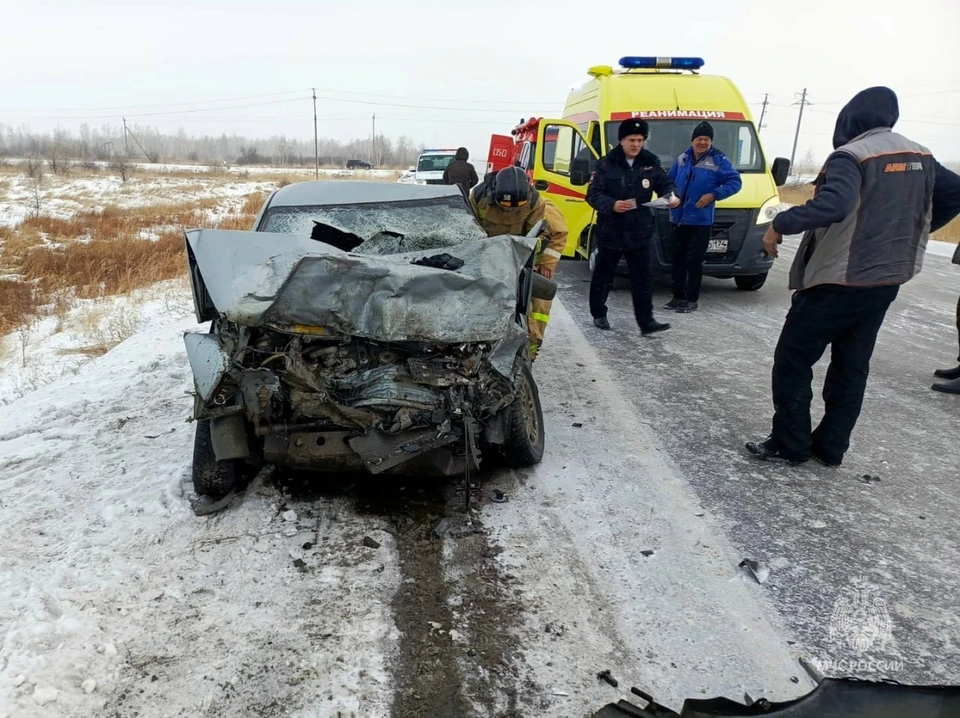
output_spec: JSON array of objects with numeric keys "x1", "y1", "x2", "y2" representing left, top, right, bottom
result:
[{"x1": 664, "y1": 122, "x2": 743, "y2": 313}]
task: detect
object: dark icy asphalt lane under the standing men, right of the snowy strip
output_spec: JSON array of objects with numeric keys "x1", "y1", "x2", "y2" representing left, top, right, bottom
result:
[{"x1": 559, "y1": 239, "x2": 960, "y2": 683}]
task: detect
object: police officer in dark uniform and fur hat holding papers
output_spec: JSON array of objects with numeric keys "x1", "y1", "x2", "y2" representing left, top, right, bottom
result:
[{"x1": 587, "y1": 119, "x2": 680, "y2": 336}]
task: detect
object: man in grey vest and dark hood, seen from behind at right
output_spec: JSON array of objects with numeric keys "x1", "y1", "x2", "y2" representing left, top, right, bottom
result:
[{"x1": 747, "y1": 87, "x2": 960, "y2": 466}]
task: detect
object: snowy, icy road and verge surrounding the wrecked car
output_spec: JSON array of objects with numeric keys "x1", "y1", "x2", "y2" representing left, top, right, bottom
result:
[{"x1": 0, "y1": 238, "x2": 960, "y2": 718}]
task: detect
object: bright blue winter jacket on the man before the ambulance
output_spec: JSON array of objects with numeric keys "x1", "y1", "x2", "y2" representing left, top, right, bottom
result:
[{"x1": 669, "y1": 147, "x2": 743, "y2": 225}]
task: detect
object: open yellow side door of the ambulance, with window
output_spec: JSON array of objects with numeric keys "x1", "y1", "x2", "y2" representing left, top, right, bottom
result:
[{"x1": 533, "y1": 120, "x2": 597, "y2": 257}]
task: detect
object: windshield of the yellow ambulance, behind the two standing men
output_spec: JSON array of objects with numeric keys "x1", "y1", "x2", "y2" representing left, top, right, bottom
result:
[{"x1": 605, "y1": 120, "x2": 764, "y2": 172}]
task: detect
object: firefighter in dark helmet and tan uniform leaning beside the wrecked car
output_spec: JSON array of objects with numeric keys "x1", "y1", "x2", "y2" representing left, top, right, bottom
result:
[{"x1": 470, "y1": 166, "x2": 567, "y2": 359}]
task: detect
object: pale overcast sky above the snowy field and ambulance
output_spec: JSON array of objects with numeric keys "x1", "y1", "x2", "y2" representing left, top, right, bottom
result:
[{"x1": 0, "y1": 0, "x2": 960, "y2": 162}]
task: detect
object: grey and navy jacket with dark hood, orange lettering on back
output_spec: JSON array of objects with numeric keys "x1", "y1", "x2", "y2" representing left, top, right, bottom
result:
[{"x1": 773, "y1": 87, "x2": 960, "y2": 289}]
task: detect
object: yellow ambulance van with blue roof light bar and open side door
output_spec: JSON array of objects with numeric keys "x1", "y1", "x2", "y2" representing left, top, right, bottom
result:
[{"x1": 488, "y1": 57, "x2": 790, "y2": 291}]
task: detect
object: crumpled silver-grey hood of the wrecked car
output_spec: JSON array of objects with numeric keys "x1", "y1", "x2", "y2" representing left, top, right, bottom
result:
[{"x1": 184, "y1": 229, "x2": 536, "y2": 344}]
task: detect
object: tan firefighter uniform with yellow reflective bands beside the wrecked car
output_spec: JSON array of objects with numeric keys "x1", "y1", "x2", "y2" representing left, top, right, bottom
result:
[{"x1": 470, "y1": 178, "x2": 567, "y2": 359}]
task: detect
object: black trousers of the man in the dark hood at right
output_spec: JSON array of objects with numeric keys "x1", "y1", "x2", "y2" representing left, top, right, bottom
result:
[{"x1": 771, "y1": 285, "x2": 900, "y2": 461}]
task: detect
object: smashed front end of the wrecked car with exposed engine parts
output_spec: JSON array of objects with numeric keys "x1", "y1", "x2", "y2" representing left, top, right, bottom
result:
[{"x1": 184, "y1": 322, "x2": 524, "y2": 476}]
